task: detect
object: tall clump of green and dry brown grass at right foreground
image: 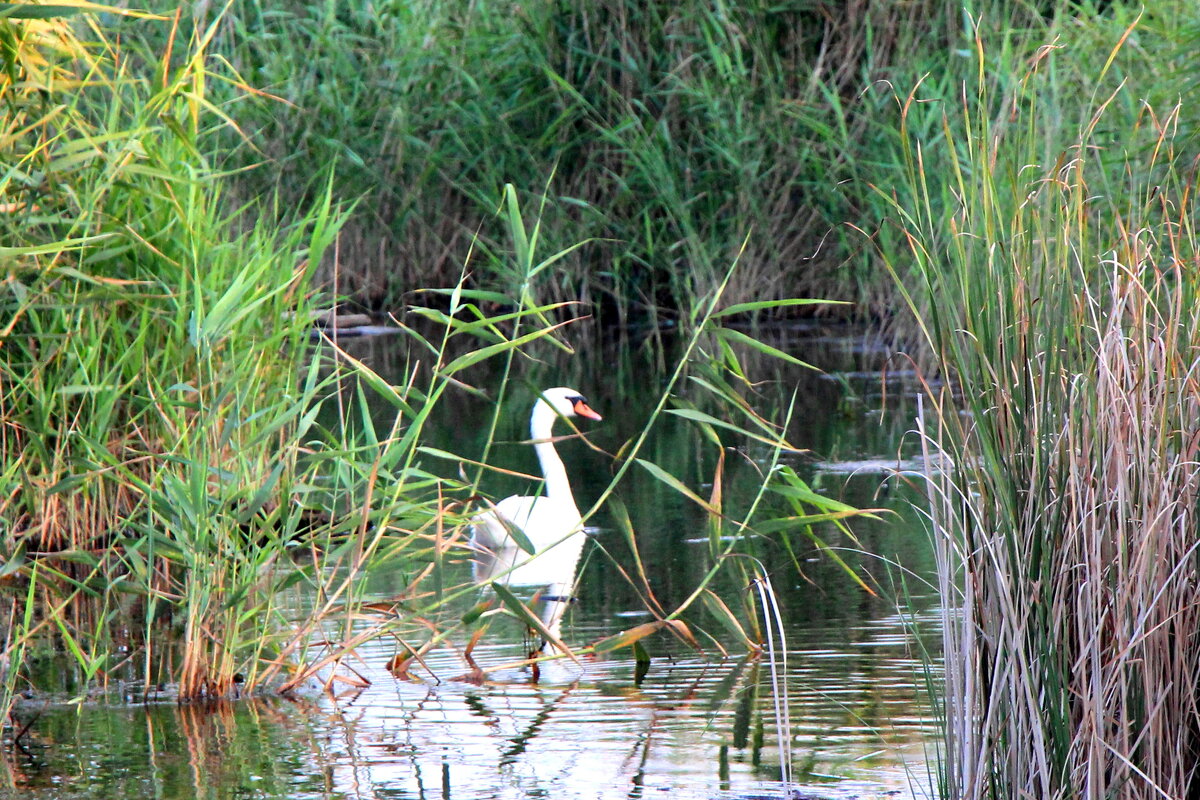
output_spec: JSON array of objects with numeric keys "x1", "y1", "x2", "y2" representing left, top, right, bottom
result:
[{"x1": 880, "y1": 4, "x2": 1200, "y2": 798}]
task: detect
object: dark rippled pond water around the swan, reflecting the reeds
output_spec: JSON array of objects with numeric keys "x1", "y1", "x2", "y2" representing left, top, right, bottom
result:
[{"x1": 0, "y1": 324, "x2": 937, "y2": 800}]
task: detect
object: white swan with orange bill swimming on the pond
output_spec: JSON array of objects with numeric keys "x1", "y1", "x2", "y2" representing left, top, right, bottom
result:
[{"x1": 470, "y1": 386, "x2": 602, "y2": 618}]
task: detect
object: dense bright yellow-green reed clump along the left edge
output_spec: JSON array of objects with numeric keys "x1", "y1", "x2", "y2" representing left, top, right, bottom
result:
[{"x1": 0, "y1": 6, "x2": 352, "y2": 706}]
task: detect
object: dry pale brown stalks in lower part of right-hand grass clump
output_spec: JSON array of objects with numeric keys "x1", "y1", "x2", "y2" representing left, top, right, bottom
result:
[{"x1": 922, "y1": 252, "x2": 1200, "y2": 800}]
